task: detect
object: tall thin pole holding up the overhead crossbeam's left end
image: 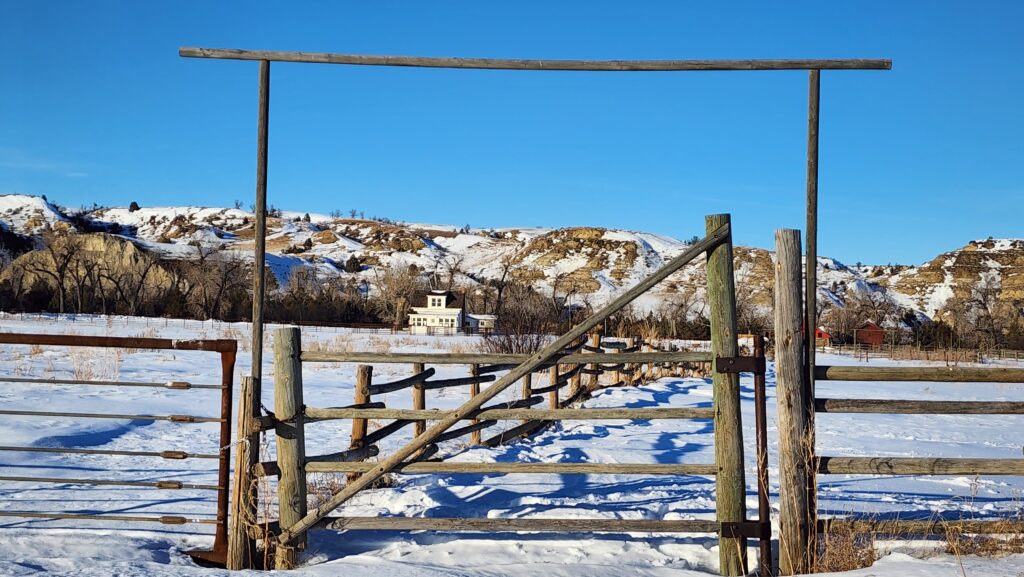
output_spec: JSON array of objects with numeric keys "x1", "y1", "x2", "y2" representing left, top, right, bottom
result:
[{"x1": 250, "y1": 60, "x2": 270, "y2": 383}]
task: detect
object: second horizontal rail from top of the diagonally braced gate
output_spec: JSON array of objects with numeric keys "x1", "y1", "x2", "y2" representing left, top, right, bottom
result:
[{"x1": 305, "y1": 407, "x2": 715, "y2": 421}]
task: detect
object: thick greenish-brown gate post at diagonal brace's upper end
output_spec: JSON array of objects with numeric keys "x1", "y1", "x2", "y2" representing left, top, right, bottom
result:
[{"x1": 705, "y1": 214, "x2": 746, "y2": 575}]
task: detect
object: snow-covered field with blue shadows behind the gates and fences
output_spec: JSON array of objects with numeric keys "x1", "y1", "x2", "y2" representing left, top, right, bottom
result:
[{"x1": 0, "y1": 316, "x2": 1024, "y2": 577}]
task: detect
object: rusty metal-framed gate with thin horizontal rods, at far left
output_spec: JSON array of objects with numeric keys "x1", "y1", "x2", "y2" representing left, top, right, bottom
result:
[{"x1": 0, "y1": 333, "x2": 238, "y2": 565}]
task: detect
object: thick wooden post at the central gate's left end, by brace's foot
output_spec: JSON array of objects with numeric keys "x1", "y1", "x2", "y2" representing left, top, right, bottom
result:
[{"x1": 273, "y1": 327, "x2": 306, "y2": 569}]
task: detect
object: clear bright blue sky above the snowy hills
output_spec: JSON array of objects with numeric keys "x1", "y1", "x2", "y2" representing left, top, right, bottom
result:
[{"x1": 0, "y1": 0, "x2": 1024, "y2": 263}]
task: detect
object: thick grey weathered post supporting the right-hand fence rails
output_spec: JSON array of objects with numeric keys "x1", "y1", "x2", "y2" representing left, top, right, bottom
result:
[{"x1": 775, "y1": 229, "x2": 814, "y2": 575}]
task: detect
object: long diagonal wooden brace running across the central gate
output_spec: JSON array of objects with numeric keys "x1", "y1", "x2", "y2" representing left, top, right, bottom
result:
[{"x1": 279, "y1": 224, "x2": 731, "y2": 544}]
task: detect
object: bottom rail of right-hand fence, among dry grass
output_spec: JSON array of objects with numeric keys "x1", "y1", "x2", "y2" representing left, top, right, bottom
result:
[{"x1": 818, "y1": 519, "x2": 1024, "y2": 535}]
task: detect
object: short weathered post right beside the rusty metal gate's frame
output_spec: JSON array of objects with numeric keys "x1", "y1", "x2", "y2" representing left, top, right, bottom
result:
[{"x1": 226, "y1": 376, "x2": 260, "y2": 571}]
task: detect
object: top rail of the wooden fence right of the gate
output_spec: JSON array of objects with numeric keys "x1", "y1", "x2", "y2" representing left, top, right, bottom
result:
[{"x1": 814, "y1": 365, "x2": 1024, "y2": 382}]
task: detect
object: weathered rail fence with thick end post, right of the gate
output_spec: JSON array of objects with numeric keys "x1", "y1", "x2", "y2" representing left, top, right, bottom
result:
[{"x1": 775, "y1": 230, "x2": 1024, "y2": 575}]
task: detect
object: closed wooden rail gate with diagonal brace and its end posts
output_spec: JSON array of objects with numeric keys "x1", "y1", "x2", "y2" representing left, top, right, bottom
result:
[{"x1": 228, "y1": 214, "x2": 770, "y2": 575}]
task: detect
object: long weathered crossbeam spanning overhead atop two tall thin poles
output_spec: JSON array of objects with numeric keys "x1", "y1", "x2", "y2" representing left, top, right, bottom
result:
[{"x1": 178, "y1": 47, "x2": 892, "y2": 72}]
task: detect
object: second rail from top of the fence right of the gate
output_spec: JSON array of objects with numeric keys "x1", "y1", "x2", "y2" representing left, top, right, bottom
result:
[{"x1": 814, "y1": 399, "x2": 1024, "y2": 415}]
